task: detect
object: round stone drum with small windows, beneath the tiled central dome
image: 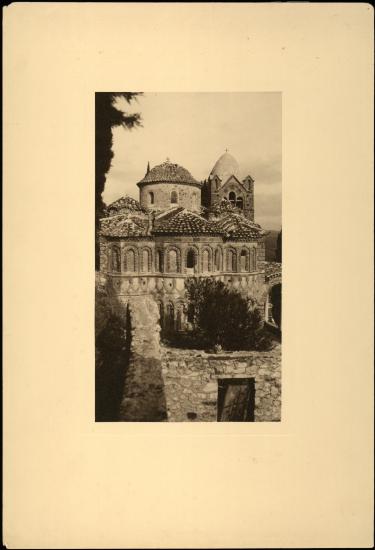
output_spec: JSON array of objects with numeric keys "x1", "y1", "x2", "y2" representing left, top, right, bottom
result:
[{"x1": 140, "y1": 183, "x2": 201, "y2": 211}]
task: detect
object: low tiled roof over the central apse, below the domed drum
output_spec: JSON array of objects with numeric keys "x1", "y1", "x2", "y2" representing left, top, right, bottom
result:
[{"x1": 153, "y1": 208, "x2": 222, "y2": 235}]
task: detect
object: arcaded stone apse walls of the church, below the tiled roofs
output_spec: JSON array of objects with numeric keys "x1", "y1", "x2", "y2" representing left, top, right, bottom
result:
[{"x1": 100, "y1": 236, "x2": 267, "y2": 330}]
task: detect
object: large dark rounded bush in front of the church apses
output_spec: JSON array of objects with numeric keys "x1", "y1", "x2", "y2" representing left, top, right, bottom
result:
[{"x1": 185, "y1": 277, "x2": 271, "y2": 350}]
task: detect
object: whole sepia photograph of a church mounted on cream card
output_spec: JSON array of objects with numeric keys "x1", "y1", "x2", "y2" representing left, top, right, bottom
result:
[{"x1": 95, "y1": 92, "x2": 282, "y2": 422}]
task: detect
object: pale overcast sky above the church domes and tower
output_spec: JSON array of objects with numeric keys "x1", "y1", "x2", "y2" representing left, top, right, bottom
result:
[{"x1": 103, "y1": 92, "x2": 281, "y2": 229}]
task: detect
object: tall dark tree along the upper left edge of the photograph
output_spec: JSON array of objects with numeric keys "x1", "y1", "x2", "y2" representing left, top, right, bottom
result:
[{"x1": 95, "y1": 92, "x2": 142, "y2": 269}]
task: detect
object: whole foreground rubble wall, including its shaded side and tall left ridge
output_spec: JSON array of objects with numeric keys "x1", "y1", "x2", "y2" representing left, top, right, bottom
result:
[{"x1": 103, "y1": 295, "x2": 281, "y2": 422}]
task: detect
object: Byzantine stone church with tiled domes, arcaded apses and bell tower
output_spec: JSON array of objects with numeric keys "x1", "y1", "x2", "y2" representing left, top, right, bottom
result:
[{"x1": 100, "y1": 151, "x2": 267, "y2": 331}]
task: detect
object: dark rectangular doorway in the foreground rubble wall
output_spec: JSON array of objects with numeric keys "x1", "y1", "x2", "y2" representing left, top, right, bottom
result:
[{"x1": 217, "y1": 378, "x2": 255, "y2": 422}]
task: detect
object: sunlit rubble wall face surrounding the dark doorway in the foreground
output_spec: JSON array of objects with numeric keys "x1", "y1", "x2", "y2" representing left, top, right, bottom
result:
[{"x1": 162, "y1": 342, "x2": 281, "y2": 422}]
